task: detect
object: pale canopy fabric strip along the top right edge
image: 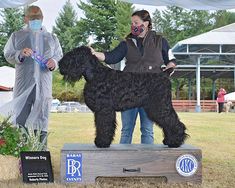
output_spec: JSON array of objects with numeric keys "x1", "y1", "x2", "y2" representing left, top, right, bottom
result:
[{"x1": 122, "y1": 0, "x2": 235, "y2": 10}]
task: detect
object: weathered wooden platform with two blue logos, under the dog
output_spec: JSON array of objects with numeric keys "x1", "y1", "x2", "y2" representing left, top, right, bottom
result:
[{"x1": 61, "y1": 144, "x2": 202, "y2": 184}]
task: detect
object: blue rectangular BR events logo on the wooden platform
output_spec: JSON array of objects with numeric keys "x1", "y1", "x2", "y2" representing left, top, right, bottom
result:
[{"x1": 66, "y1": 153, "x2": 82, "y2": 182}]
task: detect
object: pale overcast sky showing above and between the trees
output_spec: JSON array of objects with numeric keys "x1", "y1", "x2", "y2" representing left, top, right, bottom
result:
[{"x1": 33, "y1": 0, "x2": 164, "y2": 32}]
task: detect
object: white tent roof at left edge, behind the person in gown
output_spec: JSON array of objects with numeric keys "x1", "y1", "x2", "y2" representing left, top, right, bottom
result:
[{"x1": 0, "y1": 66, "x2": 15, "y2": 88}]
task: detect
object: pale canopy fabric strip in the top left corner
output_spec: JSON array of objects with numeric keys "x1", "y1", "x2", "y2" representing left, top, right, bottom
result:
[{"x1": 0, "y1": 0, "x2": 37, "y2": 8}]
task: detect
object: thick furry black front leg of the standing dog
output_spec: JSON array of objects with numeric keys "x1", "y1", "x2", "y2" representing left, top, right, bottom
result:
[{"x1": 95, "y1": 108, "x2": 116, "y2": 148}]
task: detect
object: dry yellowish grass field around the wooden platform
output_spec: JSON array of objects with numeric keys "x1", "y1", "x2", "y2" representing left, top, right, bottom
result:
[{"x1": 0, "y1": 113, "x2": 235, "y2": 188}]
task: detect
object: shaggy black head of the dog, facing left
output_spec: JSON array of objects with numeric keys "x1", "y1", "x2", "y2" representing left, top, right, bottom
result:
[{"x1": 59, "y1": 46, "x2": 97, "y2": 82}]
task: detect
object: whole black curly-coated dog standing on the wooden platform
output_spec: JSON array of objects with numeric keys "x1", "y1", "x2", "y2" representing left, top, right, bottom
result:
[{"x1": 59, "y1": 46, "x2": 188, "y2": 148}]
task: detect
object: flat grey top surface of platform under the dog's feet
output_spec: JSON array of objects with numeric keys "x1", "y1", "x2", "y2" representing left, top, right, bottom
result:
[{"x1": 61, "y1": 143, "x2": 200, "y2": 152}]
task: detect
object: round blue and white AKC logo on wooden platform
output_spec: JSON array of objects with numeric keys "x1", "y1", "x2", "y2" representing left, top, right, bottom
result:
[{"x1": 175, "y1": 154, "x2": 198, "y2": 177}]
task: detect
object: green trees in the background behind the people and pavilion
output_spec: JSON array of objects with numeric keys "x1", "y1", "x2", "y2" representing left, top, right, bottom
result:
[{"x1": 0, "y1": 0, "x2": 235, "y2": 101}]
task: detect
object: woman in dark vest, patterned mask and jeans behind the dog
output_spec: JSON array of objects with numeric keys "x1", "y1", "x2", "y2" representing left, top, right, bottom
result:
[{"x1": 92, "y1": 10, "x2": 175, "y2": 144}]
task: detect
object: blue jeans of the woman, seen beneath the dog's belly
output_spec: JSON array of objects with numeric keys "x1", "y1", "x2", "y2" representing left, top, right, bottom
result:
[{"x1": 120, "y1": 108, "x2": 154, "y2": 144}]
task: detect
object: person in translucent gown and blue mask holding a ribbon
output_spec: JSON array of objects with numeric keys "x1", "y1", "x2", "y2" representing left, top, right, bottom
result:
[{"x1": 4, "y1": 6, "x2": 63, "y2": 147}]
